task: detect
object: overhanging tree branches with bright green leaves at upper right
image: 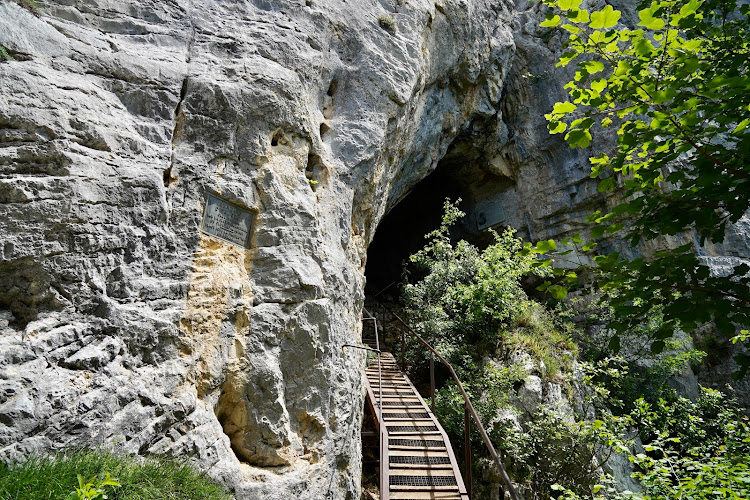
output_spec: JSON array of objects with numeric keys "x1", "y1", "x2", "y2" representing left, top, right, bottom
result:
[{"x1": 527, "y1": 0, "x2": 750, "y2": 373}]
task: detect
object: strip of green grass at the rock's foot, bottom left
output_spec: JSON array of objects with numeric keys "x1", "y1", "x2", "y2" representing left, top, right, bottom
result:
[{"x1": 0, "y1": 450, "x2": 233, "y2": 500}]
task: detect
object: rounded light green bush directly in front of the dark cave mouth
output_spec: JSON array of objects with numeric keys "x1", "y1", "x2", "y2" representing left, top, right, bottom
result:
[{"x1": 403, "y1": 200, "x2": 571, "y2": 360}]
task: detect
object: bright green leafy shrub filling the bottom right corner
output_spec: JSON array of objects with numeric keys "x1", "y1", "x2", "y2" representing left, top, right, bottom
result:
[{"x1": 556, "y1": 389, "x2": 750, "y2": 500}]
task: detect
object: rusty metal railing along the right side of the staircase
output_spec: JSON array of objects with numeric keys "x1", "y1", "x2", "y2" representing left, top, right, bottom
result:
[{"x1": 376, "y1": 302, "x2": 518, "y2": 500}]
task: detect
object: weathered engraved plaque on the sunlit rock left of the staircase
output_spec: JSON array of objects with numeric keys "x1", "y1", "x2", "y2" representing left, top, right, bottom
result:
[{"x1": 201, "y1": 194, "x2": 255, "y2": 248}]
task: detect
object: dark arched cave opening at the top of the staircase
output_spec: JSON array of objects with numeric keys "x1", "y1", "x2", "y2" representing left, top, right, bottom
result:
[{"x1": 361, "y1": 141, "x2": 515, "y2": 496}]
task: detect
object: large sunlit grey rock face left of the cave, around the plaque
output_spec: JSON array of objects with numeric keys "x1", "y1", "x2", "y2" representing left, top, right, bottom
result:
[{"x1": 0, "y1": 0, "x2": 515, "y2": 499}]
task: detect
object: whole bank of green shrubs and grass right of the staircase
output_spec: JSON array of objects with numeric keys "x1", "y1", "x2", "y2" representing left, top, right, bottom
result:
[{"x1": 402, "y1": 202, "x2": 750, "y2": 499}]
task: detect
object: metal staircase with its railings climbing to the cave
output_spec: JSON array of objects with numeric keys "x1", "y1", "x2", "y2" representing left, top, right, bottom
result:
[{"x1": 362, "y1": 309, "x2": 518, "y2": 500}]
